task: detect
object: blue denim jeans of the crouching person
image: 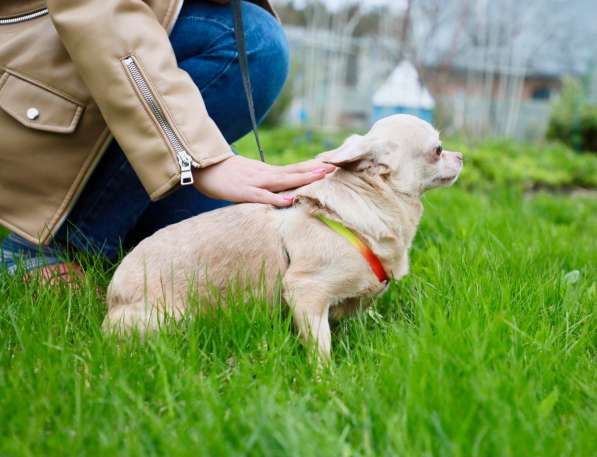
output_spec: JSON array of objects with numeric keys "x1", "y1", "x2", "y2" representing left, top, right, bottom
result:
[{"x1": 0, "y1": 0, "x2": 289, "y2": 270}]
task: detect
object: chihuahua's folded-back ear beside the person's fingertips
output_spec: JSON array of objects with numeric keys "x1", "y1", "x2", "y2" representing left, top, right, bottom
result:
[{"x1": 318, "y1": 135, "x2": 392, "y2": 174}]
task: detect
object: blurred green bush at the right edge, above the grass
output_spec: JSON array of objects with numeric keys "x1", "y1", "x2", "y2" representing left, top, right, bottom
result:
[{"x1": 547, "y1": 78, "x2": 597, "y2": 152}]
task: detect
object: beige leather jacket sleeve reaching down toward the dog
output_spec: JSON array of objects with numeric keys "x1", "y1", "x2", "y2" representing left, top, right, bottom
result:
[{"x1": 47, "y1": 0, "x2": 232, "y2": 200}]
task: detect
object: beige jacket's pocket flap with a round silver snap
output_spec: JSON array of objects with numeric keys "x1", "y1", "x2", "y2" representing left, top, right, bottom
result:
[{"x1": 0, "y1": 70, "x2": 83, "y2": 133}]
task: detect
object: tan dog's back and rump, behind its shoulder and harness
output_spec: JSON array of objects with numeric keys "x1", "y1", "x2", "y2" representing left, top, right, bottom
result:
[{"x1": 105, "y1": 204, "x2": 287, "y2": 328}]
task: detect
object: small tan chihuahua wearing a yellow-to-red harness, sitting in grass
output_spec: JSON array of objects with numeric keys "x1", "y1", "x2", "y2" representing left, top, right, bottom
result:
[{"x1": 104, "y1": 115, "x2": 462, "y2": 357}]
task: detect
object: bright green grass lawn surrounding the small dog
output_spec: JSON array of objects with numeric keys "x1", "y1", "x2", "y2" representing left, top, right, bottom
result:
[{"x1": 0, "y1": 132, "x2": 597, "y2": 457}]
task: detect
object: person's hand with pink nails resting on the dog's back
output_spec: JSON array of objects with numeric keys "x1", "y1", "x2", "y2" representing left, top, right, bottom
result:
[{"x1": 193, "y1": 155, "x2": 335, "y2": 207}]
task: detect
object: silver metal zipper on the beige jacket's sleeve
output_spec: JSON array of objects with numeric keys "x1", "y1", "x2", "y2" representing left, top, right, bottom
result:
[{"x1": 122, "y1": 56, "x2": 197, "y2": 186}]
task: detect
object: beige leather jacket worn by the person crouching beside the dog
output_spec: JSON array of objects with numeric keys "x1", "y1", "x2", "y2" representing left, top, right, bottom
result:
[{"x1": 0, "y1": 0, "x2": 272, "y2": 243}]
